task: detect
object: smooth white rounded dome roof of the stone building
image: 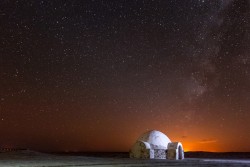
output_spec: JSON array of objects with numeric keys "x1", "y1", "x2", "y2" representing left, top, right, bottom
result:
[{"x1": 138, "y1": 130, "x2": 171, "y2": 148}]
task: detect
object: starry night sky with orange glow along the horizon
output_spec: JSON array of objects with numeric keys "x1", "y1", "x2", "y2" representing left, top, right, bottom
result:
[{"x1": 0, "y1": 0, "x2": 250, "y2": 151}]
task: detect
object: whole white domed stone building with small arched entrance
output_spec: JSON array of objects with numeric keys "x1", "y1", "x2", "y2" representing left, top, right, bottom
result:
[{"x1": 129, "y1": 130, "x2": 184, "y2": 159}]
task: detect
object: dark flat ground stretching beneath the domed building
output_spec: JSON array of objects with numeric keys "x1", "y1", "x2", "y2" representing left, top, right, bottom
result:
[{"x1": 0, "y1": 151, "x2": 250, "y2": 167}]
